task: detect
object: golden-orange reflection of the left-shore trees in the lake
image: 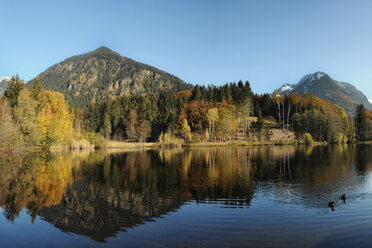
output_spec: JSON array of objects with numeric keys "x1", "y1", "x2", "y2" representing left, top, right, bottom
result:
[{"x1": 0, "y1": 153, "x2": 93, "y2": 221}]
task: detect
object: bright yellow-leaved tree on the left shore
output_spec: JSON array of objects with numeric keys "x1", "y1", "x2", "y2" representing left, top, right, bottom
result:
[{"x1": 37, "y1": 90, "x2": 73, "y2": 148}]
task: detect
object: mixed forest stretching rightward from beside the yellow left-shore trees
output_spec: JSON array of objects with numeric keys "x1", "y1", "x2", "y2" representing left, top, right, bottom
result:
[{"x1": 86, "y1": 81, "x2": 359, "y2": 143}]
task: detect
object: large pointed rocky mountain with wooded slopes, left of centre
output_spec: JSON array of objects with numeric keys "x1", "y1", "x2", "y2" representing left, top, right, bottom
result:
[{"x1": 31, "y1": 47, "x2": 192, "y2": 108}]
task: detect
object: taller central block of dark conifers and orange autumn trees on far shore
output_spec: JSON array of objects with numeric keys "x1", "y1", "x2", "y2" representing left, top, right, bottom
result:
[{"x1": 86, "y1": 82, "x2": 253, "y2": 142}]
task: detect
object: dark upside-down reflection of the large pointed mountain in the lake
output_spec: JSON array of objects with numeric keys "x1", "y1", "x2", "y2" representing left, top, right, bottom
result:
[{"x1": 38, "y1": 181, "x2": 185, "y2": 242}]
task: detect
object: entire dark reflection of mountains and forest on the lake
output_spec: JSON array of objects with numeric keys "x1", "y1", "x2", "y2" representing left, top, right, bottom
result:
[{"x1": 0, "y1": 146, "x2": 372, "y2": 242}]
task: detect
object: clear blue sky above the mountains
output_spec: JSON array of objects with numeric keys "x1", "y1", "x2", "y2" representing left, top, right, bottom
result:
[{"x1": 0, "y1": 0, "x2": 372, "y2": 99}]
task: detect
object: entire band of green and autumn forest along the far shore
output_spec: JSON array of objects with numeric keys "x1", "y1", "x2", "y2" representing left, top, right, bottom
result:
[{"x1": 0, "y1": 76, "x2": 372, "y2": 149}]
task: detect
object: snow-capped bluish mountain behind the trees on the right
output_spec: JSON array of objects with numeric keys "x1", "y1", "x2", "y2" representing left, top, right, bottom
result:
[{"x1": 279, "y1": 72, "x2": 372, "y2": 115}]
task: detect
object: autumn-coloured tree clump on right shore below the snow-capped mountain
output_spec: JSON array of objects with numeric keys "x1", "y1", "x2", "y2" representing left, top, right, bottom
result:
[{"x1": 261, "y1": 92, "x2": 353, "y2": 143}]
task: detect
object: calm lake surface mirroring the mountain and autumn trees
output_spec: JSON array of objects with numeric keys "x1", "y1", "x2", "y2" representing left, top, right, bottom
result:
[{"x1": 0, "y1": 145, "x2": 372, "y2": 247}]
